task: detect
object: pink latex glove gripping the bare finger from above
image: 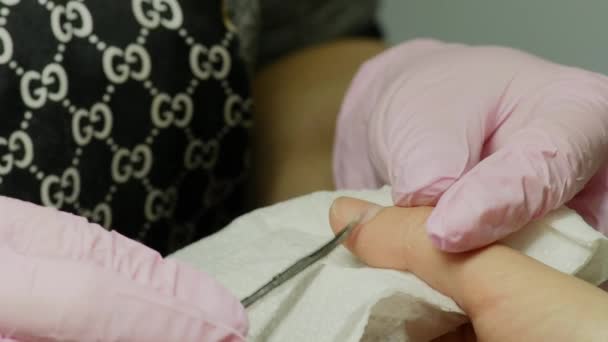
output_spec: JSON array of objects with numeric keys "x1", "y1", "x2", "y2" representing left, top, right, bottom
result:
[{"x1": 334, "y1": 40, "x2": 608, "y2": 252}]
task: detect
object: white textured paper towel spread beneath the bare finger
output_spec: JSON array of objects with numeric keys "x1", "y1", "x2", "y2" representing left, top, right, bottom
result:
[{"x1": 172, "y1": 188, "x2": 608, "y2": 342}]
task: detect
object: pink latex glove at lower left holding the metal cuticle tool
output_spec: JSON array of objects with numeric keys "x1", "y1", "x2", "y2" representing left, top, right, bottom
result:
[{"x1": 0, "y1": 197, "x2": 248, "y2": 342}]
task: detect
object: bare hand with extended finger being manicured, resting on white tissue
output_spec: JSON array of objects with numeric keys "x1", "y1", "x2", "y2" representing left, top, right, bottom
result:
[{"x1": 330, "y1": 198, "x2": 608, "y2": 342}]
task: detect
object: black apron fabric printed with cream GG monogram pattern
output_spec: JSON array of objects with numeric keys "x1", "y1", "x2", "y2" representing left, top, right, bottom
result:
[{"x1": 0, "y1": 0, "x2": 251, "y2": 253}]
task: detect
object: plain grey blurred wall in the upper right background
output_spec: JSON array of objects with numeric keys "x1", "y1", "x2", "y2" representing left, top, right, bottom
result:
[{"x1": 380, "y1": 0, "x2": 608, "y2": 75}]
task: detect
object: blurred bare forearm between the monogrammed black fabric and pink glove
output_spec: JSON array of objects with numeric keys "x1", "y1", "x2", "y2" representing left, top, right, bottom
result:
[{"x1": 251, "y1": 39, "x2": 386, "y2": 206}]
